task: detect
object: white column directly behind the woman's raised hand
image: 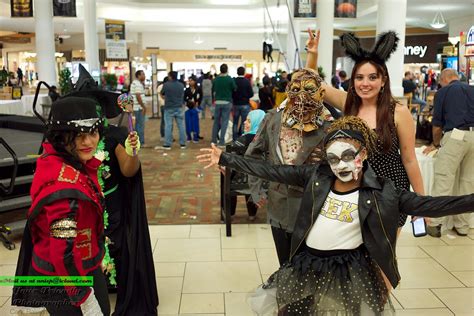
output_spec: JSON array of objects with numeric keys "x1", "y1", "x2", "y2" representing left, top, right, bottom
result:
[{"x1": 316, "y1": 0, "x2": 334, "y2": 83}]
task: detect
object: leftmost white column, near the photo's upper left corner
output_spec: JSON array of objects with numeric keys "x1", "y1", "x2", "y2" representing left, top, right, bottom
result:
[{"x1": 33, "y1": 0, "x2": 57, "y2": 85}]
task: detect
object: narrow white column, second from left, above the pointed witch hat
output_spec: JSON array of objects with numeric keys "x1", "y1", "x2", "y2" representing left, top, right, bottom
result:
[{"x1": 84, "y1": 0, "x2": 100, "y2": 74}]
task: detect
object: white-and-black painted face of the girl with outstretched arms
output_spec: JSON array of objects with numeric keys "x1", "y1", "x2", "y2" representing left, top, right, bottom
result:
[{"x1": 326, "y1": 140, "x2": 363, "y2": 182}]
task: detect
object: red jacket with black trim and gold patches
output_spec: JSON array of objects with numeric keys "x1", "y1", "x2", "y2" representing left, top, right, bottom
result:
[{"x1": 28, "y1": 143, "x2": 104, "y2": 306}]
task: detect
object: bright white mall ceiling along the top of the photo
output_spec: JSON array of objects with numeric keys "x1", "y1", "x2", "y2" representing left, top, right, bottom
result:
[{"x1": 0, "y1": 0, "x2": 474, "y2": 34}]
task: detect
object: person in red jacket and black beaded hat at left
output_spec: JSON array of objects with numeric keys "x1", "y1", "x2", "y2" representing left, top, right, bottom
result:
[{"x1": 12, "y1": 97, "x2": 110, "y2": 315}]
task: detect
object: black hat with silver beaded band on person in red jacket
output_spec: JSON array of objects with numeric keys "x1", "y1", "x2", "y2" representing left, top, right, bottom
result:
[{"x1": 47, "y1": 96, "x2": 103, "y2": 133}]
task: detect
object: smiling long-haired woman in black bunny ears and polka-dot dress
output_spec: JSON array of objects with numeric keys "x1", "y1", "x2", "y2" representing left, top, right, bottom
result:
[{"x1": 306, "y1": 31, "x2": 424, "y2": 232}]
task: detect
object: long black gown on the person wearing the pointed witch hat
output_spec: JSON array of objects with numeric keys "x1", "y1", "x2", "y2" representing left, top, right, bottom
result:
[{"x1": 102, "y1": 125, "x2": 159, "y2": 316}]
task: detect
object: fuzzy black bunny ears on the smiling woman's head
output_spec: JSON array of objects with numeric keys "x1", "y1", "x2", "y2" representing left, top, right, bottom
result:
[{"x1": 341, "y1": 31, "x2": 400, "y2": 65}]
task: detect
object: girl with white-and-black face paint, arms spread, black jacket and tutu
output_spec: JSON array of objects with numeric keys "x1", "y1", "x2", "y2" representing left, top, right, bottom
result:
[{"x1": 197, "y1": 116, "x2": 474, "y2": 316}]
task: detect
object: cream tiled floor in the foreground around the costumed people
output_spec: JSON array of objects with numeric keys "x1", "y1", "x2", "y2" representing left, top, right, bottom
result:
[{"x1": 0, "y1": 224, "x2": 474, "y2": 316}]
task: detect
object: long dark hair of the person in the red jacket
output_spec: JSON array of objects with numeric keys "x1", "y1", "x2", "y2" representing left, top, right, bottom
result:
[{"x1": 46, "y1": 126, "x2": 104, "y2": 170}]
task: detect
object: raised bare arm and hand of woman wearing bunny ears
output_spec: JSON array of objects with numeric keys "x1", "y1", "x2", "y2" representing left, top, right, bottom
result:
[{"x1": 306, "y1": 29, "x2": 347, "y2": 112}]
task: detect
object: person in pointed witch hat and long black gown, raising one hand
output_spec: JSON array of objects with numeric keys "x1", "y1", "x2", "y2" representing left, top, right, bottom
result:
[{"x1": 65, "y1": 67, "x2": 158, "y2": 316}]
